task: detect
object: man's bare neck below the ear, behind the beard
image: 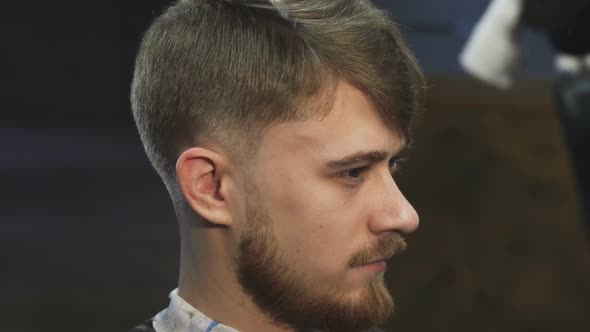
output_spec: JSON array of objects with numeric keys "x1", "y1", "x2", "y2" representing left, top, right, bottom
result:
[{"x1": 178, "y1": 222, "x2": 294, "y2": 332}]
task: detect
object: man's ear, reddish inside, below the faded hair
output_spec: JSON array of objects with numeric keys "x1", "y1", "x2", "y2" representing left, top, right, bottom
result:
[{"x1": 176, "y1": 147, "x2": 232, "y2": 226}]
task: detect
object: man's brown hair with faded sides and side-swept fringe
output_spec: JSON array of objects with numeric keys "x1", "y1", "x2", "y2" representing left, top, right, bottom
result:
[{"x1": 131, "y1": 0, "x2": 425, "y2": 200}]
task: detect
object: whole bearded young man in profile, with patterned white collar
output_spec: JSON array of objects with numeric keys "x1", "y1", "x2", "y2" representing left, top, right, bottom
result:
[{"x1": 131, "y1": 0, "x2": 424, "y2": 332}]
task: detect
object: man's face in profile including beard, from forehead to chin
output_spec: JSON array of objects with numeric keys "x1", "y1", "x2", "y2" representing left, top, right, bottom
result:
[{"x1": 236, "y1": 83, "x2": 418, "y2": 331}]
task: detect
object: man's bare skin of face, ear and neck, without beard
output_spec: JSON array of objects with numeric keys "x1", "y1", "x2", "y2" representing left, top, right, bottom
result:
[{"x1": 177, "y1": 82, "x2": 418, "y2": 331}]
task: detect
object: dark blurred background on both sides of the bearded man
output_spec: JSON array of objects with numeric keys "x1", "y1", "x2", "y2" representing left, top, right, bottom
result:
[{"x1": 0, "y1": 0, "x2": 590, "y2": 332}]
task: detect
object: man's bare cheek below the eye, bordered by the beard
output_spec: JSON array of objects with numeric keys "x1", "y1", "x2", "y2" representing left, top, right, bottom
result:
[{"x1": 266, "y1": 179, "x2": 364, "y2": 280}]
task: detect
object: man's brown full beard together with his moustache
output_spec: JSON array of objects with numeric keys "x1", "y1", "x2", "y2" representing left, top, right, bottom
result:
[{"x1": 236, "y1": 184, "x2": 406, "y2": 332}]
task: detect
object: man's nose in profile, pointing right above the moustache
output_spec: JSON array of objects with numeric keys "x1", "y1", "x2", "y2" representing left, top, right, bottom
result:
[{"x1": 369, "y1": 174, "x2": 420, "y2": 234}]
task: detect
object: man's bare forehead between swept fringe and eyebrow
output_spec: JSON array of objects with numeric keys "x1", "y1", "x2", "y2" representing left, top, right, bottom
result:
[{"x1": 260, "y1": 83, "x2": 405, "y2": 159}]
